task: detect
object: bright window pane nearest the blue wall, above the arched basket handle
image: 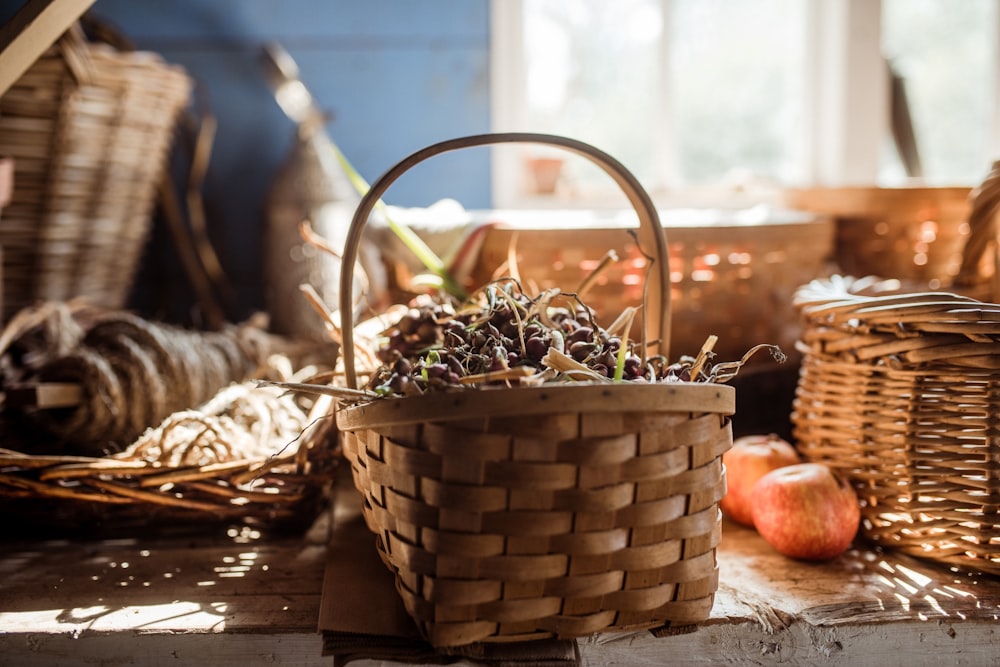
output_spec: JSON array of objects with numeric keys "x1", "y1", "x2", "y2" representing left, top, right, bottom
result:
[{"x1": 523, "y1": 0, "x2": 662, "y2": 194}]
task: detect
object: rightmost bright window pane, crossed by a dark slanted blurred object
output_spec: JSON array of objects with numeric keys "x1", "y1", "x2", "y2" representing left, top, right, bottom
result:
[{"x1": 880, "y1": 0, "x2": 998, "y2": 184}]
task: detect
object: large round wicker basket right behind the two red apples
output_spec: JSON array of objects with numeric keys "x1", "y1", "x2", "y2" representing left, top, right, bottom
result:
[{"x1": 792, "y1": 278, "x2": 1000, "y2": 574}]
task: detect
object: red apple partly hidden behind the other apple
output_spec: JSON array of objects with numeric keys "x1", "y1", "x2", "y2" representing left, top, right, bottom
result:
[{"x1": 719, "y1": 433, "x2": 801, "y2": 526}]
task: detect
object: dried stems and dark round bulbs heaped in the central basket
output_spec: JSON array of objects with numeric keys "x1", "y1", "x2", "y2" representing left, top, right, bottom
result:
[{"x1": 356, "y1": 278, "x2": 784, "y2": 396}]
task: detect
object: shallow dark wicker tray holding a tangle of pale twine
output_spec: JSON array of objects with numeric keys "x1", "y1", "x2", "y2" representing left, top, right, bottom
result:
[{"x1": 0, "y1": 383, "x2": 339, "y2": 538}]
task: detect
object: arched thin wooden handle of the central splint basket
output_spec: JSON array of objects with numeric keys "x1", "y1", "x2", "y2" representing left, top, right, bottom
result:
[{"x1": 340, "y1": 132, "x2": 670, "y2": 389}]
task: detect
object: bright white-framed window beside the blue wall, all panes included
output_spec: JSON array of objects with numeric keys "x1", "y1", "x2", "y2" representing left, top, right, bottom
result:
[{"x1": 492, "y1": 0, "x2": 1000, "y2": 207}]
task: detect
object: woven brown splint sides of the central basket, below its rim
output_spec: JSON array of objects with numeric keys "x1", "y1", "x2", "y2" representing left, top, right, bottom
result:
[{"x1": 344, "y1": 390, "x2": 732, "y2": 645}]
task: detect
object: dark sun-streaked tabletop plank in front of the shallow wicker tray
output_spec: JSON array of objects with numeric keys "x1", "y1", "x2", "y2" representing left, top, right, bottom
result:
[{"x1": 0, "y1": 517, "x2": 327, "y2": 637}]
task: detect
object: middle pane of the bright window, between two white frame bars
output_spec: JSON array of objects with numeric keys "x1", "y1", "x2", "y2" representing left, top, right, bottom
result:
[{"x1": 668, "y1": 0, "x2": 805, "y2": 184}]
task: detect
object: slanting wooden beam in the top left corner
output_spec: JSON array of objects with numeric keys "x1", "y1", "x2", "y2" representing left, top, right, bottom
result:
[{"x1": 0, "y1": 0, "x2": 94, "y2": 95}]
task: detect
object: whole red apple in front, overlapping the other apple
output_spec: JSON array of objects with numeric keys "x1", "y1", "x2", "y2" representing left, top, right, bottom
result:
[{"x1": 750, "y1": 463, "x2": 861, "y2": 560}]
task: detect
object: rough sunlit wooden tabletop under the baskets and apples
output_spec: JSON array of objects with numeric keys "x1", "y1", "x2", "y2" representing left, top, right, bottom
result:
[{"x1": 0, "y1": 482, "x2": 1000, "y2": 667}]
